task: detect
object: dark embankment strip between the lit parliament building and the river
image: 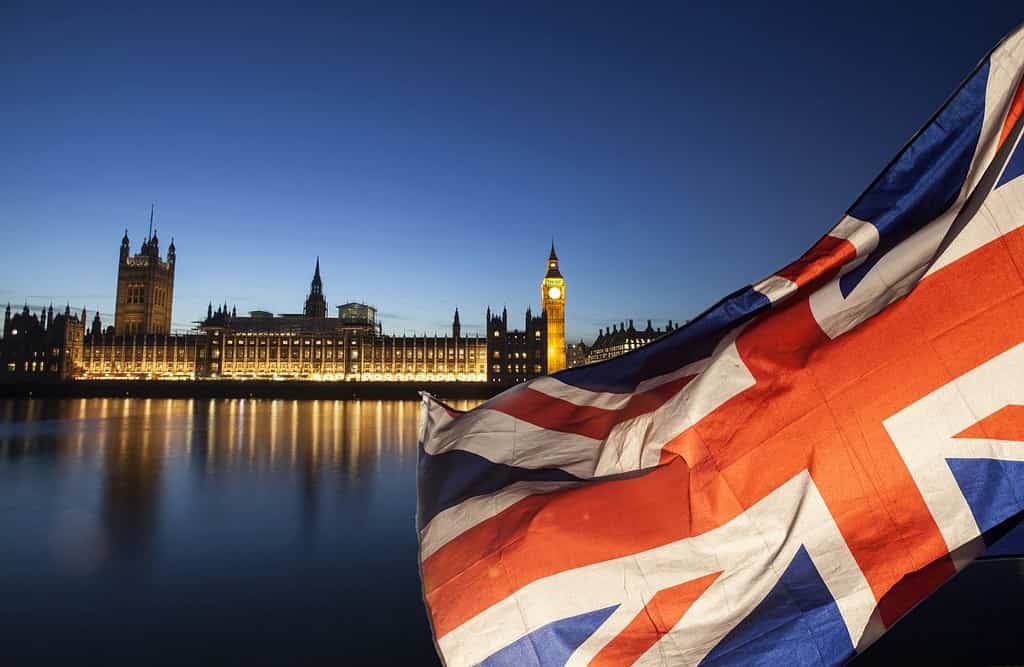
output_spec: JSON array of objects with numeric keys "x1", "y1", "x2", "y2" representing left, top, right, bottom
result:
[{"x1": 0, "y1": 380, "x2": 507, "y2": 401}]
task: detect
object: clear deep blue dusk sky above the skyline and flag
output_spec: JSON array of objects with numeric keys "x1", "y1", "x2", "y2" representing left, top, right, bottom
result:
[{"x1": 0, "y1": 0, "x2": 1024, "y2": 340}]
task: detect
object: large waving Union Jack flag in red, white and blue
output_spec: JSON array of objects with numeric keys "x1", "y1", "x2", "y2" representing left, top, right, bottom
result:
[{"x1": 418, "y1": 23, "x2": 1024, "y2": 667}]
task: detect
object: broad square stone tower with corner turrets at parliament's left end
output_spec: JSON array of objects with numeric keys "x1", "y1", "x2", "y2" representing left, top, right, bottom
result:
[{"x1": 114, "y1": 210, "x2": 175, "y2": 336}]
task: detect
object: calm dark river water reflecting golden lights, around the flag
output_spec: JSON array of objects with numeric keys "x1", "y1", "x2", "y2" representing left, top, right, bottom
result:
[{"x1": 0, "y1": 399, "x2": 1024, "y2": 665}]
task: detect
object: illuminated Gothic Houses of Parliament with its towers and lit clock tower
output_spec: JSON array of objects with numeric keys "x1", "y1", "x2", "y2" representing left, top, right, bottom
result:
[{"x1": 0, "y1": 229, "x2": 565, "y2": 384}]
